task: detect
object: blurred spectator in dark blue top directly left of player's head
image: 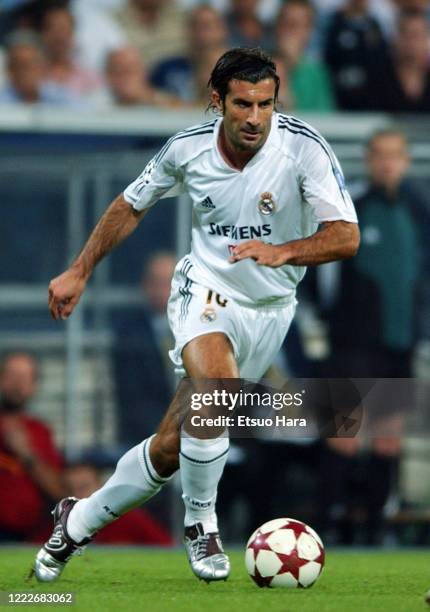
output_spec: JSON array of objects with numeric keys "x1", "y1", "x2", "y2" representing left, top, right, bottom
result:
[{"x1": 151, "y1": 4, "x2": 227, "y2": 103}]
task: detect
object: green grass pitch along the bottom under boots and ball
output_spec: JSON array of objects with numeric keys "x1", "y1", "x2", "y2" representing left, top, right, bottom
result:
[{"x1": 0, "y1": 546, "x2": 430, "y2": 612}]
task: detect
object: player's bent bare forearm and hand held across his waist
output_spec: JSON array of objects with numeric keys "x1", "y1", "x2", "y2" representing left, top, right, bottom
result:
[{"x1": 230, "y1": 220, "x2": 360, "y2": 268}]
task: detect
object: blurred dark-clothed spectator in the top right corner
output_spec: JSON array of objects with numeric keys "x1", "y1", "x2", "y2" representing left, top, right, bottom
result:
[{"x1": 372, "y1": 11, "x2": 430, "y2": 113}]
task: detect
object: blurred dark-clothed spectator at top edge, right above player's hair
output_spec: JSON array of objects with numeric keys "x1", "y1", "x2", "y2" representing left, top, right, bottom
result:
[{"x1": 227, "y1": 0, "x2": 273, "y2": 51}]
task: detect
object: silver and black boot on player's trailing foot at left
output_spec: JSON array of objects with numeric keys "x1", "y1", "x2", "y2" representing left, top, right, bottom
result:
[{"x1": 33, "y1": 497, "x2": 91, "y2": 582}]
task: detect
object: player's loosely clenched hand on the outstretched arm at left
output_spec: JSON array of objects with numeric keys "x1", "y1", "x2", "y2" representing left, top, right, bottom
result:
[{"x1": 48, "y1": 267, "x2": 87, "y2": 320}]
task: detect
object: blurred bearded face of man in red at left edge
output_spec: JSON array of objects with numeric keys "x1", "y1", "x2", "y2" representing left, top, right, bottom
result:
[{"x1": 0, "y1": 355, "x2": 37, "y2": 411}]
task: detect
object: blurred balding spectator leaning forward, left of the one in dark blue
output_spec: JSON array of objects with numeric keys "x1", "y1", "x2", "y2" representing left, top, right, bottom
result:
[{"x1": 101, "y1": 47, "x2": 188, "y2": 108}]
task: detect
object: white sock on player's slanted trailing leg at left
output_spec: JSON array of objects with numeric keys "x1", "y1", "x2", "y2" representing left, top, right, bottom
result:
[{"x1": 67, "y1": 436, "x2": 169, "y2": 543}]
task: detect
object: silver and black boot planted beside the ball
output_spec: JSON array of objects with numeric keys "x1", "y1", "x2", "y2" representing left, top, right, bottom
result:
[{"x1": 184, "y1": 523, "x2": 230, "y2": 582}]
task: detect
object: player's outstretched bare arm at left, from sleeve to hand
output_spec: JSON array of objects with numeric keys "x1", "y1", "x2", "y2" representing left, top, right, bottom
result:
[{"x1": 48, "y1": 194, "x2": 148, "y2": 319}]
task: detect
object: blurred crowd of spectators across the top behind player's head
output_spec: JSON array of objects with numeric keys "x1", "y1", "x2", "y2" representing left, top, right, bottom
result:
[{"x1": 0, "y1": 0, "x2": 430, "y2": 113}]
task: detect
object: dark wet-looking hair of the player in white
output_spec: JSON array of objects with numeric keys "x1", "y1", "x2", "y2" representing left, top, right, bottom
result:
[{"x1": 208, "y1": 47, "x2": 279, "y2": 106}]
